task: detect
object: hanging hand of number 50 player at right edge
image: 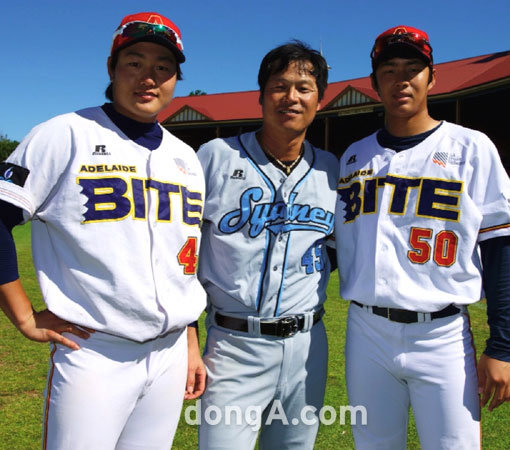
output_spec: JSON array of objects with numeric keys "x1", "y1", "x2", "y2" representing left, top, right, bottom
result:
[{"x1": 478, "y1": 354, "x2": 510, "y2": 411}]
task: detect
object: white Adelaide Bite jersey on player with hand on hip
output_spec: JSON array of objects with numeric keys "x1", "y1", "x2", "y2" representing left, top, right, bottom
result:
[{"x1": 0, "y1": 107, "x2": 205, "y2": 342}]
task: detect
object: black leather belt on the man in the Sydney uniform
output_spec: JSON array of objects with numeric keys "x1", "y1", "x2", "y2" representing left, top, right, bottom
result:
[{"x1": 214, "y1": 309, "x2": 324, "y2": 337}]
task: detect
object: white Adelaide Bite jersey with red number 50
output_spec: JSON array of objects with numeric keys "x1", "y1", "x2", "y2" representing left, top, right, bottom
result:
[{"x1": 336, "y1": 122, "x2": 510, "y2": 312}]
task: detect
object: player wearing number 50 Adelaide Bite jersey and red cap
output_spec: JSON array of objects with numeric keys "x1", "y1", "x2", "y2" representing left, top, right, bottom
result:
[{"x1": 335, "y1": 26, "x2": 510, "y2": 450}]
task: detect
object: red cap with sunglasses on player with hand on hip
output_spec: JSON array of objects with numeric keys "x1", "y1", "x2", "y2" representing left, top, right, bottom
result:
[{"x1": 110, "y1": 12, "x2": 186, "y2": 63}]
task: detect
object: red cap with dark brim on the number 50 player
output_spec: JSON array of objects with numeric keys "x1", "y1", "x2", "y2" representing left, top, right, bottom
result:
[{"x1": 370, "y1": 25, "x2": 433, "y2": 71}]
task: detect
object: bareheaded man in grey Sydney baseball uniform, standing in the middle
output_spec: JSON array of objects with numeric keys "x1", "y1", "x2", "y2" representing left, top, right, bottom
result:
[{"x1": 198, "y1": 42, "x2": 338, "y2": 450}]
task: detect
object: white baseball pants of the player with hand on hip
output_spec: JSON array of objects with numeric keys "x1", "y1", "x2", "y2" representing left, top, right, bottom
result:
[{"x1": 43, "y1": 331, "x2": 187, "y2": 450}]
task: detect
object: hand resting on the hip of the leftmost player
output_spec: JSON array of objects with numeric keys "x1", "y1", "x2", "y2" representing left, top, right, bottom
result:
[{"x1": 18, "y1": 309, "x2": 94, "y2": 350}]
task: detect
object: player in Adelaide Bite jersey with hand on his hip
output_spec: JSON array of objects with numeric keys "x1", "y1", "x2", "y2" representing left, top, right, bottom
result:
[{"x1": 0, "y1": 12, "x2": 205, "y2": 450}]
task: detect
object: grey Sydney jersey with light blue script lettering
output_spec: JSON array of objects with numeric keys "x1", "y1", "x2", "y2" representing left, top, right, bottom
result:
[{"x1": 198, "y1": 132, "x2": 338, "y2": 317}]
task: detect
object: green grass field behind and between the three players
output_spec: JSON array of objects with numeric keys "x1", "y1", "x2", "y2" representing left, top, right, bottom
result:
[{"x1": 0, "y1": 225, "x2": 510, "y2": 450}]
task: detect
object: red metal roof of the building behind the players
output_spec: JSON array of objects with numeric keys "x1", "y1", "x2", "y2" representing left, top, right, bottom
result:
[{"x1": 158, "y1": 51, "x2": 510, "y2": 123}]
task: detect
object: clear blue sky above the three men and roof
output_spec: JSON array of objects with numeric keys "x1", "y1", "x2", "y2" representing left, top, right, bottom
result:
[{"x1": 0, "y1": 0, "x2": 510, "y2": 140}]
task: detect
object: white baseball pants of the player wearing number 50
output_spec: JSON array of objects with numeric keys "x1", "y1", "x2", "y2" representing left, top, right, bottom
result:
[{"x1": 345, "y1": 304, "x2": 480, "y2": 450}]
